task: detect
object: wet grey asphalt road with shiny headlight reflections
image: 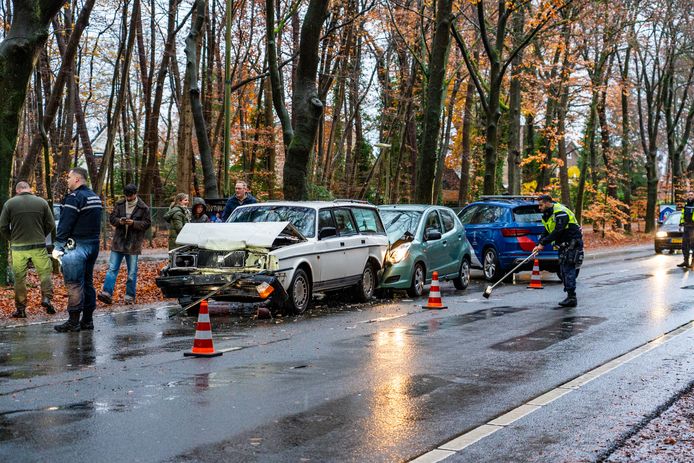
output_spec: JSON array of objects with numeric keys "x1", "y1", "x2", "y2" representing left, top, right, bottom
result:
[{"x1": 0, "y1": 248, "x2": 694, "y2": 462}]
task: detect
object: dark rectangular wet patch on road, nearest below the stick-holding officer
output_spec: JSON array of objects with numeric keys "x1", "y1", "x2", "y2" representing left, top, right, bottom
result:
[{"x1": 491, "y1": 317, "x2": 607, "y2": 352}]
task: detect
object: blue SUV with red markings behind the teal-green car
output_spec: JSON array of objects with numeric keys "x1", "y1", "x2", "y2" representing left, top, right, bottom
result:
[{"x1": 458, "y1": 196, "x2": 559, "y2": 281}]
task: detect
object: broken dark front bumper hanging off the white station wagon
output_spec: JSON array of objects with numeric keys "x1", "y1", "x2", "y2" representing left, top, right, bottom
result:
[{"x1": 156, "y1": 268, "x2": 289, "y2": 308}]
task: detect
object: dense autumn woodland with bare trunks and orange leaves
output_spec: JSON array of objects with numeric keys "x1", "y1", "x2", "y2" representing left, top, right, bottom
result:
[{"x1": 0, "y1": 0, "x2": 694, "y2": 239}]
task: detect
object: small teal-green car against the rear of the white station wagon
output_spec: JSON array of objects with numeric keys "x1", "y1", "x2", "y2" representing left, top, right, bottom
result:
[{"x1": 378, "y1": 205, "x2": 472, "y2": 297}]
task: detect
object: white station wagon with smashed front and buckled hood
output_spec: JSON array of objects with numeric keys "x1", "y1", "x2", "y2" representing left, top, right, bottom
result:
[{"x1": 156, "y1": 201, "x2": 388, "y2": 313}]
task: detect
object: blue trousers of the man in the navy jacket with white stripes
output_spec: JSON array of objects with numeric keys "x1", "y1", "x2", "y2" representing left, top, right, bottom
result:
[{"x1": 61, "y1": 239, "x2": 99, "y2": 314}]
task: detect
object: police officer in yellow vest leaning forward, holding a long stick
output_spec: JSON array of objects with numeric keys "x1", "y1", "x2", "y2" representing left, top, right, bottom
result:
[{"x1": 533, "y1": 195, "x2": 583, "y2": 307}]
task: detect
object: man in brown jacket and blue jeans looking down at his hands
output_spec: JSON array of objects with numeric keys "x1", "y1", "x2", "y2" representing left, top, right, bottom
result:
[{"x1": 97, "y1": 184, "x2": 152, "y2": 304}]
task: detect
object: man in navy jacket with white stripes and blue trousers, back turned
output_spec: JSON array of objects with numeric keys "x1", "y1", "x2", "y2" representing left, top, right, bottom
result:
[{"x1": 53, "y1": 167, "x2": 102, "y2": 333}]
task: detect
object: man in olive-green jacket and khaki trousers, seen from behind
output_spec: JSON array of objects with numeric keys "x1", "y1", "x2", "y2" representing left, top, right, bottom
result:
[{"x1": 0, "y1": 182, "x2": 55, "y2": 318}]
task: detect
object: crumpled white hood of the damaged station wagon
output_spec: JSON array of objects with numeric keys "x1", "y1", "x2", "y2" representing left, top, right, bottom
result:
[{"x1": 176, "y1": 222, "x2": 305, "y2": 251}]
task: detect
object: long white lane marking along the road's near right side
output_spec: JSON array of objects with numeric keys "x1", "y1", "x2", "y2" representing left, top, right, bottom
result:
[{"x1": 411, "y1": 320, "x2": 694, "y2": 463}]
